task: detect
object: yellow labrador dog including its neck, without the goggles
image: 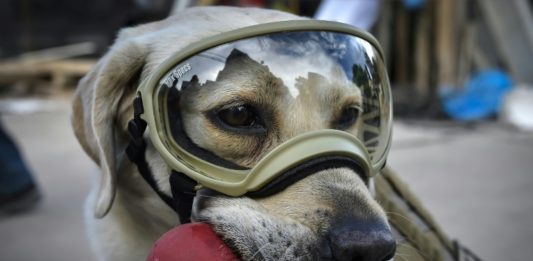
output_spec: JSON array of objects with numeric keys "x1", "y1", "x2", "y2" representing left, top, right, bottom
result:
[{"x1": 72, "y1": 7, "x2": 395, "y2": 261}]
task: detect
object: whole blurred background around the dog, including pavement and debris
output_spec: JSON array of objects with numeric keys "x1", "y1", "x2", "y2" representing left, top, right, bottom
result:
[{"x1": 0, "y1": 0, "x2": 533, "y2": 260}]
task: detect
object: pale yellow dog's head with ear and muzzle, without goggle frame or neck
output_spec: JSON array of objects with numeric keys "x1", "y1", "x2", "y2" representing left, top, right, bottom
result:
[{"x1": 73, "y1": 8, "x2": 395, "y2": 260}]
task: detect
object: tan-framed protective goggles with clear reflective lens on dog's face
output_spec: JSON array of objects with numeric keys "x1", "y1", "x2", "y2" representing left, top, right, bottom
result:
[{"x1": 139, "y1": 20, "x2": 392, "y2": 196}]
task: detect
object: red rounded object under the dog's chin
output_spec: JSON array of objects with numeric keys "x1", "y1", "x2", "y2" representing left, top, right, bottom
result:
[{"x1": 147, "y1": 223, "x2": 239, "y2": 261}]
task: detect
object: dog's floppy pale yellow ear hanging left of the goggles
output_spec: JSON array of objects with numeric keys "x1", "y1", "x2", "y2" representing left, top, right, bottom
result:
[{"x1": 72, "y1": 36, "x2": 146, "y2": 218}]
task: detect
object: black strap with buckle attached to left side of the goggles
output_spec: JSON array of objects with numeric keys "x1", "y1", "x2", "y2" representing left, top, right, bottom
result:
[{"x1": 126, "y1": 97, "x2": 196, "y2": 224}]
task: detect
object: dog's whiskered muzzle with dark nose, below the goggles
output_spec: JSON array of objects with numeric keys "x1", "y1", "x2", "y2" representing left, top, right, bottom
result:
[{"x1": 189, "y1": 160, "x2": 395, "y2": 261}]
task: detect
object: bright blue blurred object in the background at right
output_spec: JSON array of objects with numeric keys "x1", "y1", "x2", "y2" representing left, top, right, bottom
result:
[{"x1": 440, "y1": 70, "x2": 513, "y2": 121}]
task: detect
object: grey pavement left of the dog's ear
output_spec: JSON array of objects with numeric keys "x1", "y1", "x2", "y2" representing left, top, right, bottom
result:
[{"x1": 0, "y1": 98, "x2": 96, "y2": 261}]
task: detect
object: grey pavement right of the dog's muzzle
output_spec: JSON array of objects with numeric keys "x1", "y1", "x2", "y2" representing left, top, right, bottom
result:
[{"x1": 389, "y1": 122, "x2": 533, "y2": 261}]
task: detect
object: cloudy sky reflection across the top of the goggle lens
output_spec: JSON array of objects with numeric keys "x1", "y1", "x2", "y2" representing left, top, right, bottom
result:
[{"x1": 158, "y1": 31, "x2": 375, "y2": 97}]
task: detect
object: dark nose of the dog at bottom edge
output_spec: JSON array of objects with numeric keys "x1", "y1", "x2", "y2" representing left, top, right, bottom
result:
[{"x1": 329, "y1": 221, "x2": 396, "y2": 261}]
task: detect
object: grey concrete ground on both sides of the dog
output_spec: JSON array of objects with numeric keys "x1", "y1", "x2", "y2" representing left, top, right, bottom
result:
[{"x1": 0, "y1": 98, "x2": 533, "y2": 261}]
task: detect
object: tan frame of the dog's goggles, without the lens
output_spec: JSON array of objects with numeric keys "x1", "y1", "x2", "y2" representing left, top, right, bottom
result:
[{"x1": 138, "y1": 20, "x2": 392, "y2": 196}]
